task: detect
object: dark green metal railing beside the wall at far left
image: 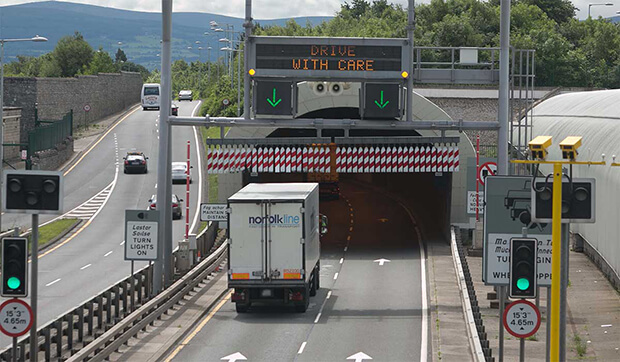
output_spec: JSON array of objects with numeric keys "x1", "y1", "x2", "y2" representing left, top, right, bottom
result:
[{"x1": 28, "y1": 111, "x2": 73, "y2": 154}]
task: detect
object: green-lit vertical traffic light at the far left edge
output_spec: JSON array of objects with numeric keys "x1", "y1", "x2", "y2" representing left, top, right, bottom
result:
[{"x1": 2, "y1": 238, "x2": 28, "y2": 297}]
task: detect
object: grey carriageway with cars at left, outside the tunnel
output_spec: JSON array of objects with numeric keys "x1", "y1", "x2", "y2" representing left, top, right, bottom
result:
[{"x1": 0, "y1": 102, "x2": 201, "y2": 346}]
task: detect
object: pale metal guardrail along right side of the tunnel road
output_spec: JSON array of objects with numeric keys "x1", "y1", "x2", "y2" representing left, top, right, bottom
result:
[{"x1": 450, "y1": 228, "x2": 485, "y2": 361}]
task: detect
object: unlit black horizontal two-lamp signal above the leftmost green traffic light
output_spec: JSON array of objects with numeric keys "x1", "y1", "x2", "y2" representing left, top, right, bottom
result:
[{"x1": 3, "y1": 170, "x2": 63, "y2": 214}]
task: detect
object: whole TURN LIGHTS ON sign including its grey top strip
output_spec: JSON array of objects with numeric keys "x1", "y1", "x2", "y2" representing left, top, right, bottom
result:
[{"x1": 125, "y1": 210, "x2": 159, "y2": 260}]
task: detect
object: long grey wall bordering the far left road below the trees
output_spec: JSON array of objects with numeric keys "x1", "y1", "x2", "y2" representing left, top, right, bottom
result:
[{"x1": 4, "y1": 72, "x2": 142, "y2": 142}]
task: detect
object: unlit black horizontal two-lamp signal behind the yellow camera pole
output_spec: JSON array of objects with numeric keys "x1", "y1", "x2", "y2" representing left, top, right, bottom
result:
[{"x1": 532, "y1": 179, "x2": 595, "y2": 223}]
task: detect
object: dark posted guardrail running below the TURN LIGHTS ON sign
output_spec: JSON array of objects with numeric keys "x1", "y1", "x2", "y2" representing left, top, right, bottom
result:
[{"x1": 0, "y1": 223, "x2": 225, "y2": 361}]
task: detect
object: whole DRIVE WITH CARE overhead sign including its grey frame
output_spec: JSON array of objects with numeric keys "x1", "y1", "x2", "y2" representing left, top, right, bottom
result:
[{"x1": 249, "y1": 36, "x2": 410, "y2": 80}]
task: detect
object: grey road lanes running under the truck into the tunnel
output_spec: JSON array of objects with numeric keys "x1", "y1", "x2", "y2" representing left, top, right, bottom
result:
[{"x1": 169, "y1": 183, "x2": 430, "y2": 362}]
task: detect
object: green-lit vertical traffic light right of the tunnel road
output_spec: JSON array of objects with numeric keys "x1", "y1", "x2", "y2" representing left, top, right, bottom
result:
[{"x1": 508, "y1": 238, "x2": 537, "y2": 298}]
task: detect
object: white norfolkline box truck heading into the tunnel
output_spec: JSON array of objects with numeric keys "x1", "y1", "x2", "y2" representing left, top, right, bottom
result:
[{"x1": 228, "y1": 183, "x2": 327, "y2": 313}]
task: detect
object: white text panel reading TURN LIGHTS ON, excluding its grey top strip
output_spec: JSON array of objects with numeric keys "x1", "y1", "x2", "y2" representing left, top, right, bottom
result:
[{"x1": 125, "y1": 221, "x2": 157, "y2": 260}]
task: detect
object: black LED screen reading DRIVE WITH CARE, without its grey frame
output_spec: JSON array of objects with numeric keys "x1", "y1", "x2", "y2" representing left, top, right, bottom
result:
[{"x1": 256, "y1": 43, "x2": 402, "y2": 72}]
